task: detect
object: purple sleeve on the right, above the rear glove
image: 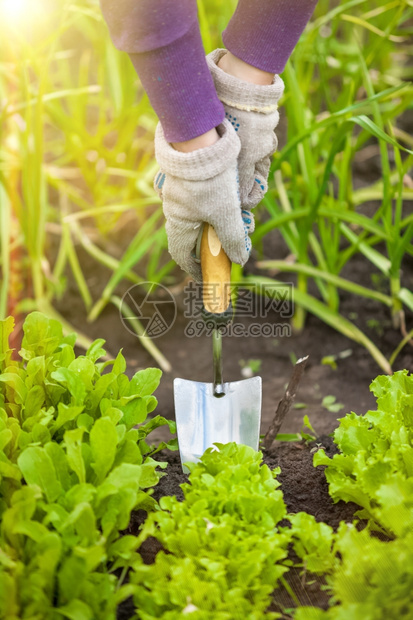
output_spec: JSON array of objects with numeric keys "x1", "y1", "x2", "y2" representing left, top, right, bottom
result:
[{"x1": 222, "y1": 0, "x2": 317, "y2": 73}]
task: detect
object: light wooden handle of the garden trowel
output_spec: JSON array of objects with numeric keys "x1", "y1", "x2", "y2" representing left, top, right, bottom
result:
[{"x1": 201, "y1": 223, "x2": 231, "y2": 315}]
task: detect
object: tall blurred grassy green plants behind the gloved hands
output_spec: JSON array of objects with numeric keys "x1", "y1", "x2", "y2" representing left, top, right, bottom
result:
[{"x1": 0, "y1": 0, "x2": 413, "y2": 372}]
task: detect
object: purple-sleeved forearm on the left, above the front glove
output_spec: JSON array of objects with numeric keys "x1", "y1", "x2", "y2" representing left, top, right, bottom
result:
[{"x1": 100, "y1": 0, "x2": 225, "y2": 143}]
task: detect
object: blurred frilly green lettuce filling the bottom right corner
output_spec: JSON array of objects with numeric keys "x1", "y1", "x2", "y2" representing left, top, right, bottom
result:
[{"x1": 289, "y1": 498, "x2": 413, "y2": 620}]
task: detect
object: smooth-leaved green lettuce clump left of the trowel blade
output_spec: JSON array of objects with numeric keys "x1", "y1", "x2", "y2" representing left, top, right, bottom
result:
[{"x1": 0, "y1": 312, "x2": 174, "y2": 620}]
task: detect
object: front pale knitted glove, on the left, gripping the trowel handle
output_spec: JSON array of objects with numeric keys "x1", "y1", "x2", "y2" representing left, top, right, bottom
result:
[{"x1": 154, "y1": 119, "x2": 253, "y2": 282}]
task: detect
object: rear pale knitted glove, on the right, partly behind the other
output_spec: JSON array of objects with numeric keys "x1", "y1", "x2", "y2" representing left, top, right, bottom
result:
[{"x1": 206, "y1": 49, "x2": 284, "y2": 209}]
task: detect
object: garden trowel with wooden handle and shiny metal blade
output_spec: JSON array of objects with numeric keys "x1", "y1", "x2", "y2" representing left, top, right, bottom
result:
[{"x1": 174, "y1": 224, "x2": 261, "y2": 471}]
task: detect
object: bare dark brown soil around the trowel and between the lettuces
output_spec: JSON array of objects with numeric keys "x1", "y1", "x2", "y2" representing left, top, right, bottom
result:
[{"x1": 52, "y1": 251, "x2": 413, "y2": 620}]
